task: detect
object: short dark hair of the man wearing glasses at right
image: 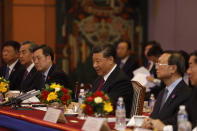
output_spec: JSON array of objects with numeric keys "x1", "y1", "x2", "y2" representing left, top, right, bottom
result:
[{"x1": 168, "y1": 52, "x2": 185, "y2": 76}]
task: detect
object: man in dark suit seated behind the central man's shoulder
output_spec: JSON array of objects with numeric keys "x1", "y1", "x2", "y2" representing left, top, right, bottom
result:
[{"x1": 116, "y1": 41, "x2": 139, "y2": 79}]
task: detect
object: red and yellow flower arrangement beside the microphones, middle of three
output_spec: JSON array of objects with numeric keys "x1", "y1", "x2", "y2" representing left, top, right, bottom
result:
[{"x1": 38, "y1": 83, "x2": 72, "y2": 105}]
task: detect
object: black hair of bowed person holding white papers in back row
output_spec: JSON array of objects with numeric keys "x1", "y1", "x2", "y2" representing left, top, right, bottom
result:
[{"x1": 147, "y1": 44, "x2": 163, "y2": 57}]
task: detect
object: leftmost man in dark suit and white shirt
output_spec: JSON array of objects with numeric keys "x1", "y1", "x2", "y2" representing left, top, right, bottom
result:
[{"x1": 0, "y1": 41, "x2": 25, "y2": 90}]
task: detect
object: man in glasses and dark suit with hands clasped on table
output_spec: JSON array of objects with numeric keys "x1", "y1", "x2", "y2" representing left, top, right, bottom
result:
[{"x1": 144, "y1": 52, "x2": 191, "y2": 128}]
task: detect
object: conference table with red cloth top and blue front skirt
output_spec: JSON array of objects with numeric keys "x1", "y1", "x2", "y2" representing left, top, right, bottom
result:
[{"x1": 0, "y1": 106, "x2": 114, "y2": 131}]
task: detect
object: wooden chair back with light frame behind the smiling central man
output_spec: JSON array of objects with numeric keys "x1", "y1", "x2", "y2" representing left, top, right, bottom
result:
[{"x1": 131, "y1": 81, "x2": 146, "y2": 116}]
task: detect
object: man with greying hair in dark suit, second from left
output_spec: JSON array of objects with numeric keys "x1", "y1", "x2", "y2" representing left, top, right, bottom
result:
[{"x1": 19, "y1": 41, "x2": 44, "y2": 92}]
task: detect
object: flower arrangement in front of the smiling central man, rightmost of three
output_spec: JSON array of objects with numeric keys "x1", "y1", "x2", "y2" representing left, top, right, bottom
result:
[{"x1": 80, "y1": 91, "x2": 113, "y2": 116}]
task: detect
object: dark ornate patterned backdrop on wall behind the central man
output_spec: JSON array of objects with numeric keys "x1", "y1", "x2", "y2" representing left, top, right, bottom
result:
[{"x1": 56, "y1": 0, "x2": 146, "y2": 83}]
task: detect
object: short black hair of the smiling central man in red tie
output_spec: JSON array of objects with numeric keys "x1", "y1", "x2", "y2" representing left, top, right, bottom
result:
[{"x1": 92, "y1": 44, "x2": 116, "y2": 60}]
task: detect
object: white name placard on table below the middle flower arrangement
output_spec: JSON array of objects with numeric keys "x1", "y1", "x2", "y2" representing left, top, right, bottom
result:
[{"x1": 43, "y1": 107, "x2": 67, "y2": 123}]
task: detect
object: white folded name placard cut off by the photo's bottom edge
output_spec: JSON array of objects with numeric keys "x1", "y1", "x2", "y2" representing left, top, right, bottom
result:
[{"x1": 82, "y1": 117, "x2": 111, "y2": 131}]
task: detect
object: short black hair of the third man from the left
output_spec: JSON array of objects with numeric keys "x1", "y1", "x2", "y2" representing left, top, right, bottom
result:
[{"x1": 33, "y1": 44, "x2": 54, "y2": 61}]
